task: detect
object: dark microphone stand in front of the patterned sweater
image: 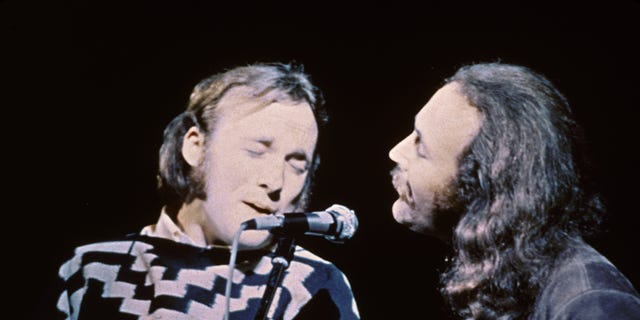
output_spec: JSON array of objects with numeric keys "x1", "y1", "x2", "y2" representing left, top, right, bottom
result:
[{"x1": 254, "y1": 235, "x2": 296, "y2": 320}]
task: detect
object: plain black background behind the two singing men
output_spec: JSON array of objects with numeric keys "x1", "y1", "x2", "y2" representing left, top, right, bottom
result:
[{"x1": 0, "y1": 1, "x2": 640, "y2": 319}]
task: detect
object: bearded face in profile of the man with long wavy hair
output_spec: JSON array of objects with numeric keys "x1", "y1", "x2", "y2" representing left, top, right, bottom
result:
[{"x1": 389, "y1": 82, "x2": 482, "y2": 240}]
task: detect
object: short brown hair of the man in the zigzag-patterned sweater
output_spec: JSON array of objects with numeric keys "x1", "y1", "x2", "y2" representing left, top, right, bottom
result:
[{"x1": 158, "y1": 63, "x2": 328, "y2": 216}]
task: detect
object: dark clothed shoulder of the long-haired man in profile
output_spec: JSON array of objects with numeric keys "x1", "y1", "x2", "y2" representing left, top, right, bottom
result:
[{"x1": 536, "y1": 245, "x2": 640, "y2": 319}]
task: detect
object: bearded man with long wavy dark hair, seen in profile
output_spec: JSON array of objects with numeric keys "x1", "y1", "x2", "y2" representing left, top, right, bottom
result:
[{"x1": 389, "y1": 63, "x2": 640, "y2": 319}]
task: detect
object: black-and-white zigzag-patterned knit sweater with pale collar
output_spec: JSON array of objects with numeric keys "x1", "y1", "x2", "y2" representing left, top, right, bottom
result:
[{"x1": 57, "y1": 235, "x2": 359, "y2": 320}]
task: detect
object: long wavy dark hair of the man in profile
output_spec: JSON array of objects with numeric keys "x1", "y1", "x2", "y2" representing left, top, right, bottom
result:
[{"x1": 441, "y1": 63, "x2": 604, "y2": 319}]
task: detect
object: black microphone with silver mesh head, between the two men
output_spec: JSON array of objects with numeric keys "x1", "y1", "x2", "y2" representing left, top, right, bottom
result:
[{"x1": 243, "y1": 204, "x2": 358, "y2": 242}]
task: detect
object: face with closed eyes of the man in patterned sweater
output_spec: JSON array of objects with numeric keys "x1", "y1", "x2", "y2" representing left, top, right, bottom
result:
[{"x1": 203, "y1": 102, "x2": 318, "y2": 249}]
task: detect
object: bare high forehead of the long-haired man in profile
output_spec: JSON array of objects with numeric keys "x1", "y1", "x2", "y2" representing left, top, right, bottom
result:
[{"x1": 415, "y1": 82, "x2": 482, "y2": 154}]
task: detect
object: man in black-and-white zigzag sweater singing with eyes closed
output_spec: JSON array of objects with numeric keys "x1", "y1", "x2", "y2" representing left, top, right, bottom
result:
[{"x1": 57, "y1": 63, "x2": 359, "y2": 320}]
